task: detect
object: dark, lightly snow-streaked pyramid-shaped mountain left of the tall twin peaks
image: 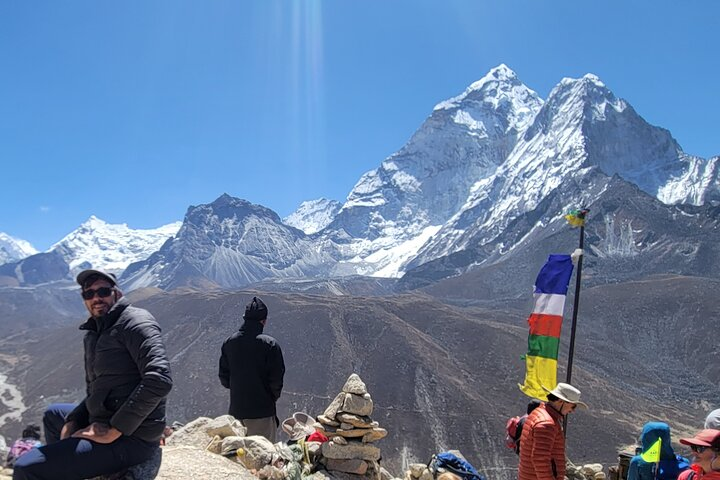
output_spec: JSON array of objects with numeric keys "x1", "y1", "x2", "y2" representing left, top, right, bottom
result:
[{"x1": 122, "y1": 195, "x2": 332, "y2": 289}]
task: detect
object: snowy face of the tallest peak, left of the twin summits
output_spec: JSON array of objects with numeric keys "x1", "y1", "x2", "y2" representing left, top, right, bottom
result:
[{"x1": 324, "y1": 65, "x2": 542, "y2": 276}]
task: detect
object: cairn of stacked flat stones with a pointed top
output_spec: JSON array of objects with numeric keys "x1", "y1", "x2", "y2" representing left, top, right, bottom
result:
[{"x1": 315, "y1": 373, "x2": 387, "y2": 479}]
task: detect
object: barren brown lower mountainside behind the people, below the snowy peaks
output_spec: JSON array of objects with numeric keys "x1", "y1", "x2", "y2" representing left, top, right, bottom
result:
[{"x1": 0, "y1": 286, "x2": 720, "y2": 480}]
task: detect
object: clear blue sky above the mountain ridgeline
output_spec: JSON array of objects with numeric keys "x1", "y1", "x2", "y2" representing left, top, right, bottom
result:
[{"x1": 0, "y1": 0, "x2": 720, "y2": 249}]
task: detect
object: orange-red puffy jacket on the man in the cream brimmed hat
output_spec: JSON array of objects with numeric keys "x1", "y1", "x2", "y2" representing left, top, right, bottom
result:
[{"x1": 518, "y1": 403, "x2": 565, "y2": 480}]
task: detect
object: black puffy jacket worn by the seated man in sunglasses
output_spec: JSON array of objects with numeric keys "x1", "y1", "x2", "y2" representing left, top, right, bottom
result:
[{"x1": 67, "y1": 298, "x2": 172, "y2": 442}]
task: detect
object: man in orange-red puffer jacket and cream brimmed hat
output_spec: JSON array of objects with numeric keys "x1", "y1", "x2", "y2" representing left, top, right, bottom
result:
[{"x1": 518, "y1": 383, "x2": 588, "y2": 480}]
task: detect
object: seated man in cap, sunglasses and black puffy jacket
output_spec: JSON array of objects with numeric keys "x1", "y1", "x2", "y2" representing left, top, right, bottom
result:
[{"x1": 13, "y1": 270, "x2": 172, "y2": 480}]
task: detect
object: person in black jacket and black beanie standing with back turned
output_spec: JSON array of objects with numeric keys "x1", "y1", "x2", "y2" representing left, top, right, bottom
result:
[{"x1": 219, "y1": 297, "x2": 285, "y2": 443}]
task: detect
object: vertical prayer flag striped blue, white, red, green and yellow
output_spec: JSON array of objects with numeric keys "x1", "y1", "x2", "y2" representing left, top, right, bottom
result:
[{"x1": 518, "y1": 255, "x2": 573, "y2": 399}]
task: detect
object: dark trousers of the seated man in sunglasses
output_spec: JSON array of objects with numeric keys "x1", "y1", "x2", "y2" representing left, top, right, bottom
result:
[{"x1": 13, "y1": 405, "x2": 158, "y2": 480}]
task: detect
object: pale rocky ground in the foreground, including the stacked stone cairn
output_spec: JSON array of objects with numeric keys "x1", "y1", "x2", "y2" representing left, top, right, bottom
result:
[{"x1": 0, "y1": 374, "x2": 620, "y2": 480}]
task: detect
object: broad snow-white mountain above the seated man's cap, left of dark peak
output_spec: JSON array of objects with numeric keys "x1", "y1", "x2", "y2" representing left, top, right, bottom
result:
[{"x1": 49, "y1": 215, "x2": 181, "y2": 272}]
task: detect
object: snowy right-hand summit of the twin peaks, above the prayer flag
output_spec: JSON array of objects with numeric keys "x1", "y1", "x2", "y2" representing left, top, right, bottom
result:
[{"x1": 408, "y1": 75, "x2": 717, "y2": 268}]
